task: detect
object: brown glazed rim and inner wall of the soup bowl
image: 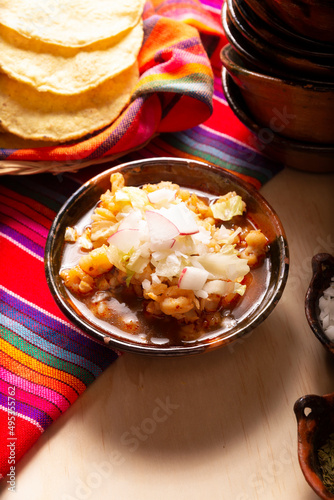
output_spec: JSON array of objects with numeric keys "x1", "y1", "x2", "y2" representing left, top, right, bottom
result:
[{"x1": 44, "y1": 158, "x2": 289, "y2": 356}]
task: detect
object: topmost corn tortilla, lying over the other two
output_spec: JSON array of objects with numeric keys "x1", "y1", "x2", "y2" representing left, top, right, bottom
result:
[{"x1": 0, "y1": 0, "x2": 144, "y2": 47}]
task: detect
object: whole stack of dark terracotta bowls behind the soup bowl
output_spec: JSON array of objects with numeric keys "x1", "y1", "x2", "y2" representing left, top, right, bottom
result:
[{"x1": 221, "y1": 0, "x2": 334, "y2": 172}]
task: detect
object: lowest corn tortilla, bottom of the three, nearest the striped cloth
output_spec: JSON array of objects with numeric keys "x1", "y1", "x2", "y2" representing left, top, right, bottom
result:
[{"x1": 0, "y1": 62, "x2": 139, "y2": 142}]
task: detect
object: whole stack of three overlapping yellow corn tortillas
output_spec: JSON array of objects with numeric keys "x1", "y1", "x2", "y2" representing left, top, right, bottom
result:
[{"x1": 0, "y1": 0, "x2": 144, "y2": 147}]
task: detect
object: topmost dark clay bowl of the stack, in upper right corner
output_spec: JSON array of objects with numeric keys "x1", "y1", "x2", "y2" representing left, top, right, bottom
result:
[{"x1": 266, "y1": 0, "x2": 334, "y2": 44}]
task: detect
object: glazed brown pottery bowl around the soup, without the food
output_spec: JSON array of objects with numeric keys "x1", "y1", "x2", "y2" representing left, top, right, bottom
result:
[{"x1": 45, "y1": 158, "x2": 288, "y2": 356}]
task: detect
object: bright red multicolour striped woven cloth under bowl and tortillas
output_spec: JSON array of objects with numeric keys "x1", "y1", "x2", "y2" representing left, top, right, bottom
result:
[{"x1": 0, "y1": 0, "x2": 281, "y2": 477}]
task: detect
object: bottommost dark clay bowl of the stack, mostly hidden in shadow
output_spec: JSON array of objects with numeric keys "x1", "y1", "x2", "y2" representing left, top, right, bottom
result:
[{"x1": 222, "y1": 68, "x2": 334, "y2": 173}]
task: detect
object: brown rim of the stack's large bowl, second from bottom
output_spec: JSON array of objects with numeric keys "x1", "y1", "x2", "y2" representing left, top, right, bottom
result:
[{"x1": 220, "y1": 44, "x2": 334, "y2": 92}]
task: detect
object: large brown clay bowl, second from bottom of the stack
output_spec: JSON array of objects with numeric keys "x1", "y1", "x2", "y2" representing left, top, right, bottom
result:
[{"x1": 221, "y1": 41, "x2": 334, "y2": 144}]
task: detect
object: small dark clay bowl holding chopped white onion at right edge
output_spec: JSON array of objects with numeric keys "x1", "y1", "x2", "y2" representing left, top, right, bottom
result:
[{"x1": 305, "y1": 253, "x2": 334, "y2": 354}]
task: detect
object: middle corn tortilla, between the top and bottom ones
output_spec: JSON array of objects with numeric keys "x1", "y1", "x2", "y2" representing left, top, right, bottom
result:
[{"x1": 0, "y1": 20, "x2": 143, "y2": 95}]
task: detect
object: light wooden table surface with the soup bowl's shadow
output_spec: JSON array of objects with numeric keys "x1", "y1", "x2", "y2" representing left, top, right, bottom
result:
[{"x1": 0, "y1": 169, "x2": 334, "y2": 500}]
